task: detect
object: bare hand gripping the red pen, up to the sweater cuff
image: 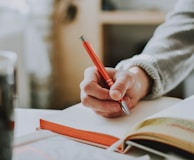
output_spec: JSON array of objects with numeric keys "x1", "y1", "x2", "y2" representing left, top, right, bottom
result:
[{"x1": 80, "y1": 67, "x2": 151, "y2": 117}]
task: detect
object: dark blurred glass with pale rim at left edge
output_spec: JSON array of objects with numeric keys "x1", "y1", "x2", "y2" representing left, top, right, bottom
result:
[{"x1": 0, "y1": 51, "x2": 17, "y2": 160}]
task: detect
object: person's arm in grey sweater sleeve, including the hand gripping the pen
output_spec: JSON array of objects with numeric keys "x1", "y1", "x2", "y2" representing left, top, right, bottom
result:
[{"x1": 80, "y1": 0, "x2": 194, "y2": 117}]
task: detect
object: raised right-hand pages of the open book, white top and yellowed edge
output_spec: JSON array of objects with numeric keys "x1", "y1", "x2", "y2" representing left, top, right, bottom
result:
[{"x1": 126, "y1": 96, "x2": 194, "y2": 153}]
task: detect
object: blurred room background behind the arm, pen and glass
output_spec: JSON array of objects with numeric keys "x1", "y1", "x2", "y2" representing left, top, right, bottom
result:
[{"x1": 0, "y1": 0, "x2": 194, "y2": 109}]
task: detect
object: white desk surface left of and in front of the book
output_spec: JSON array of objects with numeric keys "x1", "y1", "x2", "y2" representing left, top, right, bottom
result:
[{"x1": 13, "y1": 109, "x2": 149, "y2": 160}]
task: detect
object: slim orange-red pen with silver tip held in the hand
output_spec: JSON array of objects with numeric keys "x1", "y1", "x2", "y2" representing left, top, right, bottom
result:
[{"x1": 80, "y1": 35, "x2": 130, "y2": 115}]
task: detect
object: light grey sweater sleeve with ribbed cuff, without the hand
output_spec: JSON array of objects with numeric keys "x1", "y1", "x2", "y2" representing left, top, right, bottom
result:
[{"x1": 116, "y1": 0, "x2": 194, "y2": 98}]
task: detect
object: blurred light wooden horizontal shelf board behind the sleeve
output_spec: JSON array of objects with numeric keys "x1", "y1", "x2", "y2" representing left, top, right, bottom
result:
[{"x1": 99, "y1": 10, "x2": 166, "y2": 25}]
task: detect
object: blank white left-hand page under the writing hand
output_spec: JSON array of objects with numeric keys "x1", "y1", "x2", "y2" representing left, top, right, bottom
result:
[{"x1": 42, "y1": 97, "x2": 181, "y2": 138}]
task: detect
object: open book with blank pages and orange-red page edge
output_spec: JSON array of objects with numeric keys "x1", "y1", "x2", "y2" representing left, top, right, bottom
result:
[{"x1": 40, "y1": 96, "x2": 194, "y2": 157}]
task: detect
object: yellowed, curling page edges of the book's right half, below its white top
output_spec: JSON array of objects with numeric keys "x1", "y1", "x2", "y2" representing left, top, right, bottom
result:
[{"x1": 126, "y1": 118, "x2": 194, "y2": 154}]
